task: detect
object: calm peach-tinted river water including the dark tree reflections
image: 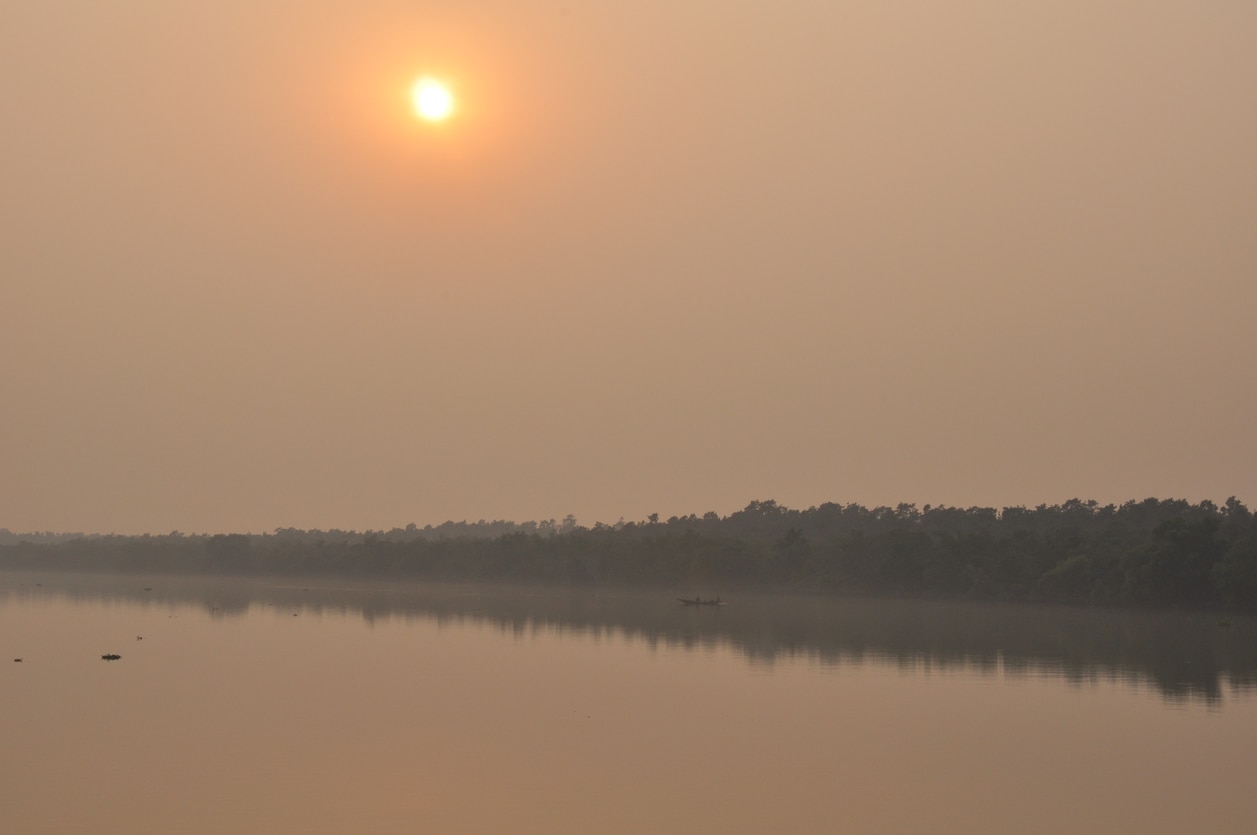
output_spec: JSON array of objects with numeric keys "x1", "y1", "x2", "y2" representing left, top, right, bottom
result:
[{"x1": 0, "y1": 573, "x2": 1257, "y2": 835}]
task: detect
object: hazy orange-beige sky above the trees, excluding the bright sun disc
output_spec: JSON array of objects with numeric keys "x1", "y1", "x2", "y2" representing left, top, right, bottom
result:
[{"x1": 0, "y1": 0, "x2": 1257, "y2": 533}]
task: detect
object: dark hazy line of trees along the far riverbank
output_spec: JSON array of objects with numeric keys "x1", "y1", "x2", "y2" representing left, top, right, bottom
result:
[{"x1": 0, "y1": 498, "x2": 1257, "y2": 610}]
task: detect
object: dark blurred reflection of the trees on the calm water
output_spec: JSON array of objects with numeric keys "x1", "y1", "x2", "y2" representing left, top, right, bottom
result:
[{"x1": 0, "y1": 572, "x2": 1257, "y2": 704}]
